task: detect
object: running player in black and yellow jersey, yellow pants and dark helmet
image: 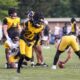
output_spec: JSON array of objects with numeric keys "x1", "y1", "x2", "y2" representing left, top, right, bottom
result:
[{"x1": 17, "y1": 12, "x2": 44, "y2": 73}]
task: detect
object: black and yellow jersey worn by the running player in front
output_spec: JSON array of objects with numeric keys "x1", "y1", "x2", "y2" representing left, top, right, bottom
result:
[{"x1": 20, "y1": 21, "x2": 44, "y2": 41}]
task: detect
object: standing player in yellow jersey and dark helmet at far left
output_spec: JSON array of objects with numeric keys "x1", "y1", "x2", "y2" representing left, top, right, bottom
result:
[{"x1": 3, "y1": 8, "x2": 21, "y2": 40}]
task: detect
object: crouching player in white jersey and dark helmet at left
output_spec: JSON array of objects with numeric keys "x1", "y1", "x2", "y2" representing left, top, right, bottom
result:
[{"x1": 4, "y1": 34, "x2": 19, "y2": 68}]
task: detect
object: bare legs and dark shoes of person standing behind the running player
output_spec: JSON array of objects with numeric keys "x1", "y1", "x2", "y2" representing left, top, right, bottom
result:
[{"x1": 31, "y1": 34, "x2": 48, "y2": 67}]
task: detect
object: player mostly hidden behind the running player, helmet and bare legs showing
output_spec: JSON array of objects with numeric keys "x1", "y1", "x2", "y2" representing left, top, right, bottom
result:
[{"x1": 23, "y1": 11, "x2": 48, "y2": 67}]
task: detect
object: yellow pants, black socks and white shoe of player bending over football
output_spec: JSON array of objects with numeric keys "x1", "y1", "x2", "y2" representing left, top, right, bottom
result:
[{"x1": 52, "y1": 35, "x2": 80, "y2": 69}]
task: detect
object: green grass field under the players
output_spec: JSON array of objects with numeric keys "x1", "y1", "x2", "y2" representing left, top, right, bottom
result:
[{"x1": 0, "y1": 45, "x2": 80, "y2": 80}]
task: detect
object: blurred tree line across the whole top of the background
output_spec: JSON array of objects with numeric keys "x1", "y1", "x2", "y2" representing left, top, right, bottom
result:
[{"x1": 0, "y1": 0, "x2": 80, "y2": 18}]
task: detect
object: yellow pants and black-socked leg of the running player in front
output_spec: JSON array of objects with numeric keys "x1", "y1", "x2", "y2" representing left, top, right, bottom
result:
[{"x1": 17, "y1": 39, "x2": 33, "y2": 73}]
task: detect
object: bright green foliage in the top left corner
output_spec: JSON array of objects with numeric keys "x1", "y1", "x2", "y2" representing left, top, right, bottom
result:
[{"x1": 0, "y1": 0, "x2": 18, "y2": 19}]
